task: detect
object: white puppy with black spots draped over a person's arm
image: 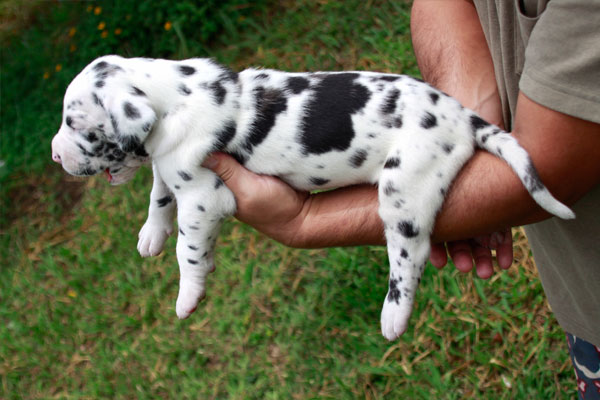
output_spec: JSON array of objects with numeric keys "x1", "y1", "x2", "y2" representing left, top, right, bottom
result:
[{"x1": 52, "y1": 56, "x2": 574, "y2": 340}]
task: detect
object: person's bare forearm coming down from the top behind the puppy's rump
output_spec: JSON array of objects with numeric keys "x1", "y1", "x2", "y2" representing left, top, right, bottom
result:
[{"x1": 411, "y1": 0, "x2": 503, "y2": 126}]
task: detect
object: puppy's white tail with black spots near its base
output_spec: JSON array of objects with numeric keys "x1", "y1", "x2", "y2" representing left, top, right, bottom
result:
[{"x1": 470, "y1": 114, "x2": 575, "y2": 219}]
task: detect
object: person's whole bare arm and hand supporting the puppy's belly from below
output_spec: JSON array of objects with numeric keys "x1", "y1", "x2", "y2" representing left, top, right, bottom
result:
[{"x1": 205, "y1": 95, "x2": 600, "y2": 248}]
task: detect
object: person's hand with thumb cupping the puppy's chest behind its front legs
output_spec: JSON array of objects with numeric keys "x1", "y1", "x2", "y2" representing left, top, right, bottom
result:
[{"x1": 202, "y1": 153, "x2": 309, "y2": 246}]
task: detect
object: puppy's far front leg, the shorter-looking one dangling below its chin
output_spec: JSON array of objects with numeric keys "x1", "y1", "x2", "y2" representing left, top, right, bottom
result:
[{"x1": 137, "y1": 163, "x2": 176, "y2": 257}]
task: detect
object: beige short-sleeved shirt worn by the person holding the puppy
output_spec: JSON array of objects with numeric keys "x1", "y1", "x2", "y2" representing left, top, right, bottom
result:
[{"x1": 474, "y1": 0, "x2": 600, "y2": 346}]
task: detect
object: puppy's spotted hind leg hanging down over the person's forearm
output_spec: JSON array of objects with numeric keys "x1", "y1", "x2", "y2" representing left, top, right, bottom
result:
[{"x1": 379, "y1": 144, "x2": 472, "y2": 340}]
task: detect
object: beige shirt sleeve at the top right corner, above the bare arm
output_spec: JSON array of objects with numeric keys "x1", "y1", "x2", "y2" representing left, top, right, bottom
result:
[{"x1": 519, "y1": 0, "x2": 600, "y2": 123}]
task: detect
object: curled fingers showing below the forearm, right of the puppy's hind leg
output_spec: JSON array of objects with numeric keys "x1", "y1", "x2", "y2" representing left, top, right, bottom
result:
[{"x1": 430, "y1": 229, "x2": 513, "y2": 279}]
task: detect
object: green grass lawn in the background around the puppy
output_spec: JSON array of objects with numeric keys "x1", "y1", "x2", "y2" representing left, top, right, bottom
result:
[{"x1": 0, "y1": 1, "x2": 575, "y2": 399}]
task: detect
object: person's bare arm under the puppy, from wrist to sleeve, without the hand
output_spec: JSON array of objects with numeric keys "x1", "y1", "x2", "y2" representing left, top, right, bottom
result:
[{"x1": 292, "y1": 95, "x2": 600, "y2": 247}]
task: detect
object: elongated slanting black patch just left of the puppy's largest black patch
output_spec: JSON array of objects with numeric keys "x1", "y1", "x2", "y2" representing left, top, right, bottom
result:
[{"x1": 245, "y1": 86, "x2": 287, "y2": 153}]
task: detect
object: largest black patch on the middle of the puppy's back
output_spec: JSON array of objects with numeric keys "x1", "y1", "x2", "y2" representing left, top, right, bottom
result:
[{"x1": 300, "y1": 73, "x2": 371, "y2": 154}]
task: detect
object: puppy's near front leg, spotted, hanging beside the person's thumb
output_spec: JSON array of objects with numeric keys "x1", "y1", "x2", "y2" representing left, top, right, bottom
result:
[{"x1": 173, "y1": 168, "x2": 235, "y2": 319}]
